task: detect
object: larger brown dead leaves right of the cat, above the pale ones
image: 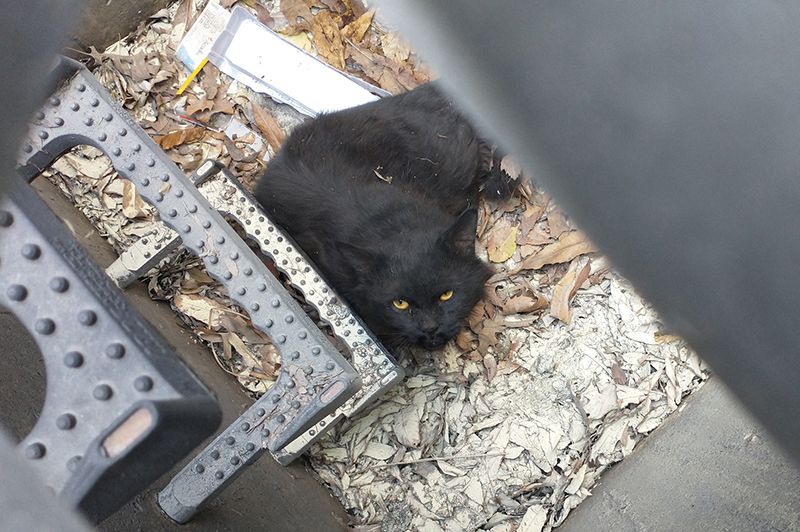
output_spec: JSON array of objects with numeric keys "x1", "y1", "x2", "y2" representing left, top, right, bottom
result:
[{"x1": 456, "y1": 170, "x2": 608, "y2": 381}]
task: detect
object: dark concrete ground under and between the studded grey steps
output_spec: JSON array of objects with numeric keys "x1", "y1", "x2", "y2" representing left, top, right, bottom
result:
[{"x1": 0, "y1": 178, "x2": 348, "y2": 532}]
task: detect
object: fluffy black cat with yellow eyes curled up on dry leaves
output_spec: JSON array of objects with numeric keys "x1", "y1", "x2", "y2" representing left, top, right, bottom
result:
[{"x1": 256, "y1": 85, "x2": 508, "y2": 349}]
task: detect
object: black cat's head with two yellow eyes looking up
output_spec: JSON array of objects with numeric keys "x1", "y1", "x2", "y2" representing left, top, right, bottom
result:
[{"x1": 344, "y1": 209, "x2": 489, "y2": 349}]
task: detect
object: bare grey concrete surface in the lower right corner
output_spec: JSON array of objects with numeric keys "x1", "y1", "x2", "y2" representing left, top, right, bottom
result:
[{"x1": 559, "y1": 378, "x2": 800, "y2": 532}]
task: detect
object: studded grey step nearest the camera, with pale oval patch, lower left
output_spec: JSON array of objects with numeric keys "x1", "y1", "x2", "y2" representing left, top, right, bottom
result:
[{"x1": 0, "y1": 171, "x2": 221, "y2": 522}]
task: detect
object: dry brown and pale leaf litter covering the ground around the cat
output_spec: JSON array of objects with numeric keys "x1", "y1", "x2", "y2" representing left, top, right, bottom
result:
[{"x1": 48, "y1": 0, "x2": 707, "y2": 532}]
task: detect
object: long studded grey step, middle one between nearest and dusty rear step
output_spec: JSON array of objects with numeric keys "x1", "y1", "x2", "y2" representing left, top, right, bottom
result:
[{"x1": 19, "y1": 59, "x2": 360, "y2": 511}]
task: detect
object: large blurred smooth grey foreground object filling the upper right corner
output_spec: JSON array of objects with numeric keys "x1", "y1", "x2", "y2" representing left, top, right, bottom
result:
[{"x1": 379, "y1": 0, "x2": 800, "y2": 458}]
